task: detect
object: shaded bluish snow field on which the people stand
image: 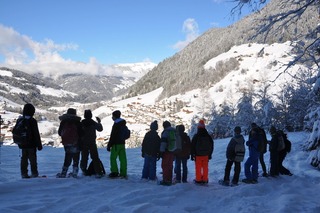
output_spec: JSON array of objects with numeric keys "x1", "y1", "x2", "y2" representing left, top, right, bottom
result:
[{"x1": 0, "y1": 133, "x2": 320, "y2": 213}]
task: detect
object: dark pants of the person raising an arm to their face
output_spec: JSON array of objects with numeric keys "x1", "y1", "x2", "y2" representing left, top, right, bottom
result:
[{"x1": 80, "y1": 143, "x2": 103, "y2": 175}]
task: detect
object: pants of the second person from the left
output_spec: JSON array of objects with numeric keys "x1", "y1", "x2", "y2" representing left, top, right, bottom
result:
[{"x1": 61, "y1": 146, "x2": 80, "y2": 175}]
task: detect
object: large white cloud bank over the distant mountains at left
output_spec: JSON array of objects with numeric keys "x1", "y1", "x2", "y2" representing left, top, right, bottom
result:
[{"x1": 0, "y1": 24, "x2": 123, "y2": 76}]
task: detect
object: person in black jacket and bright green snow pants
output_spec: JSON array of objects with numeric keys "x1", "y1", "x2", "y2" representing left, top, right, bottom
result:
[{"x1": 107, "y1": 110, "x2": 127, "y2": 178}]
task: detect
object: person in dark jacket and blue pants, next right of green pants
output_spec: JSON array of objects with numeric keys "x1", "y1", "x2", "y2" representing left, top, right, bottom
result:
[{"x1": 141, "y1": 121, "x2": 160, "y2": 181}]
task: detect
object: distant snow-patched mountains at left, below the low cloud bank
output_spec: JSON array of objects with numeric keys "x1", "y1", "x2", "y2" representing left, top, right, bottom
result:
[{"x1": 0, "y1": 62, "x2": 156, "y2": 106}]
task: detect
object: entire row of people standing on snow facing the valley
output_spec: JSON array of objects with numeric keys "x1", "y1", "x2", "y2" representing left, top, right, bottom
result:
[{"x1": 15, "y1": 103, "x2": 292, "y2": 185}]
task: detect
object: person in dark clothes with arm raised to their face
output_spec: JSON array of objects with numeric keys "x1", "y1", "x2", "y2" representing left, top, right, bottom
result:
[{"x1": 80, "y1": 109, "x2": 103, "y2": 178}]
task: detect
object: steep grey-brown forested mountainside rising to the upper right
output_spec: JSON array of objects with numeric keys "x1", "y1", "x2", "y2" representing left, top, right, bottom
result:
[{"x1": 128, "y1": 0, "x2": 319, "y2": 98}]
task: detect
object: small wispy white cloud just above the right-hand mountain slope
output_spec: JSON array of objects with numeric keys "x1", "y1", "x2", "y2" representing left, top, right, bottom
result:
[{"x1": 173, "y1": 18, "x2": 199, "y2": 50}]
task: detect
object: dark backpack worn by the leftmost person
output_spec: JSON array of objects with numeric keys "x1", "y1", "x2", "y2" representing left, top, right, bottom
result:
[{"x1": 12, "y1": 117, "x2": 31, "y2": 145}]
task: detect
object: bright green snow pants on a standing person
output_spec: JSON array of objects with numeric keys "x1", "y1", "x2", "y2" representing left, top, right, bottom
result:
[{"x1": 110, "y1": 144, "x2": 127, "y2": 177}]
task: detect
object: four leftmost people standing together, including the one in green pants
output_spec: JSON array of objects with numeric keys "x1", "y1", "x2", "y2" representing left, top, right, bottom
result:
[{"x1": 15, "y1": 103, "x2": 127, "y2": 178}]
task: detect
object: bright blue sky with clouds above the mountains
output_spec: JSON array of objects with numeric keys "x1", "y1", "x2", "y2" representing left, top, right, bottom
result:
[{"x1": 0, "y1": 0, "x2": 268, "y2": 76}]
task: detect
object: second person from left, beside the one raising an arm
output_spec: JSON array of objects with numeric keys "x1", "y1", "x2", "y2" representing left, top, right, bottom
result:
[{"x1": 57, "y1": 108, "x2": 82, "y2": 178}]
